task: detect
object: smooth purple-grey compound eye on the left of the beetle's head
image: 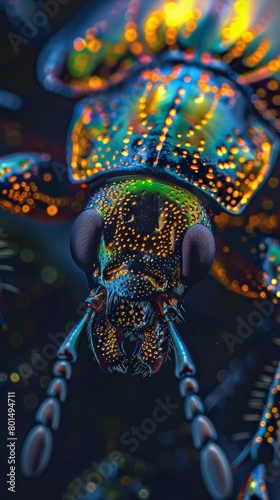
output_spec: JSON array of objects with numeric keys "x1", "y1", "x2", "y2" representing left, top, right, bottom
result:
[{"x1": 70, "y1": 208, "x2": 103, "y2": 272}]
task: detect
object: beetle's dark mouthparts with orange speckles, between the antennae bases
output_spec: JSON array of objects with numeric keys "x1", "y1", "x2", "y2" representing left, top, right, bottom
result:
[{"x1": 87, "y1": 300, "x2": 170, "y2": 376}]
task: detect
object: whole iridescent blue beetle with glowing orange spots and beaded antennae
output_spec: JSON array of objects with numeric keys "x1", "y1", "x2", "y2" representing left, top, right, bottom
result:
[{"x1": 1, "y1": 0, "x2": 280, "y2": 499}]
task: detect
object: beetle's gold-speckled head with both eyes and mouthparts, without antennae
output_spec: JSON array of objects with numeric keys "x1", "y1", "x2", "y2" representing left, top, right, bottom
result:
[{"x1": 71, "y1": 183, "x2": 214, "y2": 372}]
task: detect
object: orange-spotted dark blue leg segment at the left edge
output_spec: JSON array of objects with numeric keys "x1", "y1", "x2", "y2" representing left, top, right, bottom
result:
[{"x1": 0, "y1": 153, "x2": 89, "y2": 222}]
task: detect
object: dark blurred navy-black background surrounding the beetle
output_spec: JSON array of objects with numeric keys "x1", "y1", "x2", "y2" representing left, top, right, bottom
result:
[{"x1": 0, "y1": 0, "x2": 280, "y2": 500}]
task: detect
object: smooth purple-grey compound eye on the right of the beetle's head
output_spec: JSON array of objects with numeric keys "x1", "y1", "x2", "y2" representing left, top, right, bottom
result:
[{"x1": 181, "y1": 224, "x2": 215, "y2": 286}]
